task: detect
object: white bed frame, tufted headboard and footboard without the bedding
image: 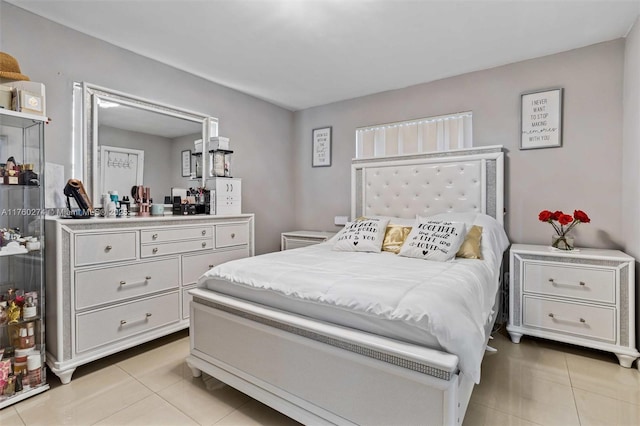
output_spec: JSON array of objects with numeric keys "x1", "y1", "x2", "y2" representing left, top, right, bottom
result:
[{"x1": 187, "y1": 146, "x2": 504, "y2": 425}]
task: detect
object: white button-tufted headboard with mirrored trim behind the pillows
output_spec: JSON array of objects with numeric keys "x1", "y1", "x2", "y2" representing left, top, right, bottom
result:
[{"x1": 351, "y1": 146, "x2": 504, "y2": 225}]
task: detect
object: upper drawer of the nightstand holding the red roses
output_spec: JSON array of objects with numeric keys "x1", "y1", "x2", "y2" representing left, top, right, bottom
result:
[{"x1": 524, "y1": 262, "x2": 616, "y2": 303}]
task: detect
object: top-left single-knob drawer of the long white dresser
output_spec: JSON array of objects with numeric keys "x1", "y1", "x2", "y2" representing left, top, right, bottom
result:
[{"x1": 75, "y1": 231, "x2": 136, "y2": 266}]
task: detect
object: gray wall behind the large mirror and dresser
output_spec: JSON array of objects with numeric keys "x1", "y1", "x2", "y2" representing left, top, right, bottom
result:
[{"x1": 0, "y1": 2, "x2": 294, "y2": 253}]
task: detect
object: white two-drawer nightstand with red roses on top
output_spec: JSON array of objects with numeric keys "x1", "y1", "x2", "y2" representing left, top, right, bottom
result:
[{"x1": 507, "y1": 244, "x2": 640, "y2": 368}]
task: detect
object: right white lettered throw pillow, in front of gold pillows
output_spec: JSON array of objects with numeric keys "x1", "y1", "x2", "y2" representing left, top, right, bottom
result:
[{"x1": 399, "y1": 220, "x2": 465, "y2": 262}]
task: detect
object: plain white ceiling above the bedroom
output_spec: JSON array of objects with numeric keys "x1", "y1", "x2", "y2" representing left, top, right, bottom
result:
[{"x1": 8, "y1": 0, "x2": 640, "y2": 111}]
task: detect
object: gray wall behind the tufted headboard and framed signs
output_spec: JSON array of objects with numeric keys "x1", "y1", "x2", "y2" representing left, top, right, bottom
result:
[{"x1": 293, "y1": 39, "x2": 624, "y2": 247}]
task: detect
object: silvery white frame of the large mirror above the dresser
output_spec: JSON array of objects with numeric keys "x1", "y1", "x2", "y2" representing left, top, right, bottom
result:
[{"x1": 71, "y1": 82, "x2": 218, "y2": 207}]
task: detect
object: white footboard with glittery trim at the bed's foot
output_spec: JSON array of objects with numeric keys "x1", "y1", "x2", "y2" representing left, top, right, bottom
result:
[{"x1": 187, "y1": 289, "x2": 473, "y2": 425}]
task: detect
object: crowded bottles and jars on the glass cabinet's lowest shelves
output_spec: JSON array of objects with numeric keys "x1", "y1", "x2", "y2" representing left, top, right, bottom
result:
[{"x1": 0, "y1": 288, "x2": 44, "y2": 401}]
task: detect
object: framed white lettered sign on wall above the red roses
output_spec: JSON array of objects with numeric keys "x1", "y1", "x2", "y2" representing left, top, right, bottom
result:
[{"x1": 520, "y1": 88, "x2": 563, "y2": 149}]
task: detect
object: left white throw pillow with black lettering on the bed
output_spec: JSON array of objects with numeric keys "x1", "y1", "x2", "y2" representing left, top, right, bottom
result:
[{"x1": 333, "y1": 218, "x2": 389, "y2": 252}]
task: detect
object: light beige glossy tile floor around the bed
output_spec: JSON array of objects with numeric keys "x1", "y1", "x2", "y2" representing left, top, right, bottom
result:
[{"x1": 0, "y1": 332, "x2": 640, "y2": 426}]
